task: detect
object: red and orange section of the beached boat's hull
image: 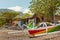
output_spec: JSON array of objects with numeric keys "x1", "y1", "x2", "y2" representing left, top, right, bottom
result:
[{"x1": 28, "y1": 27, "x2": 54, "y2": 36}]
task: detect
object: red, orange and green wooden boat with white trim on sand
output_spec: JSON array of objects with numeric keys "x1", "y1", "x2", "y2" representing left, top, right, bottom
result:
[{"x1": 28, "y1": 22, "x2": 59, "y2": 36}]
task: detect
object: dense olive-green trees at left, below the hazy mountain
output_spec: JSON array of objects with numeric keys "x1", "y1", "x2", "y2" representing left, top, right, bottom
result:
[{"x1": 0, "y1": 12, "x2": 20, "y2": 26}]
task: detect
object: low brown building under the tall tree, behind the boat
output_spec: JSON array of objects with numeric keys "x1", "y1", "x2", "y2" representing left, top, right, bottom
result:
[{"x1": 13, "y1": 14, "x2": 60, "y2": 25}]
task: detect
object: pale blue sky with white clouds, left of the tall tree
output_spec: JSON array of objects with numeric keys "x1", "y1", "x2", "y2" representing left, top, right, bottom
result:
[{"x1": 0, "y1": 0, "x2": 31, "y2": 12}]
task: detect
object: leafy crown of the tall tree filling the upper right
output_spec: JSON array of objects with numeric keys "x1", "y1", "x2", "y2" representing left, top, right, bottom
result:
[{"x1": 30, "y1": 0, "x2": 60, "y2": 19}]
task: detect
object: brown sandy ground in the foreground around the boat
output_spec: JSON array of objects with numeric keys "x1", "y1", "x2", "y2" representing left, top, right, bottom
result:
[{"x1": 0, "y1": 30, "x2": 60, "y2": 40}]
